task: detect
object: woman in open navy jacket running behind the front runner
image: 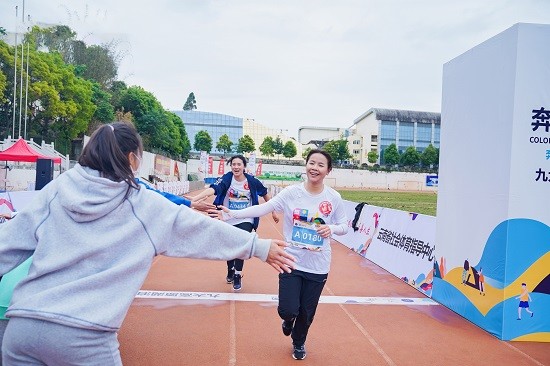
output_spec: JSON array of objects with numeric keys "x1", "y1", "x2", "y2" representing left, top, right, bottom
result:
[{"x1": 191, "y1": 155, "x2": 279, "y2": 291}]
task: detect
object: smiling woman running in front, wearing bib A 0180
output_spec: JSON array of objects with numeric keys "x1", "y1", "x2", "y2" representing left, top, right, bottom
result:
[{"x1": 216, "y1": 149, "x2": 348, "y2": 360}]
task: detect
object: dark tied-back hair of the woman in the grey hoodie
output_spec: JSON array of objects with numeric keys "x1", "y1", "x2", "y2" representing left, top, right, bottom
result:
[{"x1": 78, "y1": 122, "x2": 143, "y2": 198}]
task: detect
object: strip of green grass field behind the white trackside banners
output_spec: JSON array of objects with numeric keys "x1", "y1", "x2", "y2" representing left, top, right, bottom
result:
[{"x1": 338, "y1": 189, "x2": 437, "y2": 216}]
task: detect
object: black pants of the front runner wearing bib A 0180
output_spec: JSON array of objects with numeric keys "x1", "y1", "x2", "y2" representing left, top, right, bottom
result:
[{"x1": 277, "y1": 270, "x2": 328, "y2": 346}]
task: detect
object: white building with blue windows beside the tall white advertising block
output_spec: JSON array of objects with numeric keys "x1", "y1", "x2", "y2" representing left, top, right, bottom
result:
[{"x1": 348, "y1": 108, "x2": 441, "y2": 164}]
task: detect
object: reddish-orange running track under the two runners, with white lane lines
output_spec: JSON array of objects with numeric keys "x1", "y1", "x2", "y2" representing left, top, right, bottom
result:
[{"x1": 119, "y1": 194, "x2": 550, "y2": 366}]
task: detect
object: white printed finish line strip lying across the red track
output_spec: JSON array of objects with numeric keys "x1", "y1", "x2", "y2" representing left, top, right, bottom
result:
[{"x1": 135, "y1": 290, "x2": 439, "y2": 306}]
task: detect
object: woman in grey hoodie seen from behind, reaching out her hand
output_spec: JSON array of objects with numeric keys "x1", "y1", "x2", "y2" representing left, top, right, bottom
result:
[{"x1": 0, "y1": 123, "x2": 294, "y2": 366}]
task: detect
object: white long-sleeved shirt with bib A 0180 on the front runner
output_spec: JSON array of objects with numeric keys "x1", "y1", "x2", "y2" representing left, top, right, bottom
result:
[{"x1": 231, "y1": 183, "x2": 348, "y2": 274}]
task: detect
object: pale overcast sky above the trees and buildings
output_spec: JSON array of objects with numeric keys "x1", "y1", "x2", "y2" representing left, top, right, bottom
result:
[{"x1": 0, "y1": 0, "x2": 550, "y2": 137}]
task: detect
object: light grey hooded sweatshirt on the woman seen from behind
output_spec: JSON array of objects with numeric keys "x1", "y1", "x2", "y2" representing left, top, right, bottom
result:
[{"x1": 0, "y1": 164, "x2": 271, "y2": 331}]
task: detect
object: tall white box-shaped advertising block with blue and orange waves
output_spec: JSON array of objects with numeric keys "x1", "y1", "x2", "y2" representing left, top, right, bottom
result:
[{"x1": 432, "y1": 24, "x2": 550, "y2": 342}]
